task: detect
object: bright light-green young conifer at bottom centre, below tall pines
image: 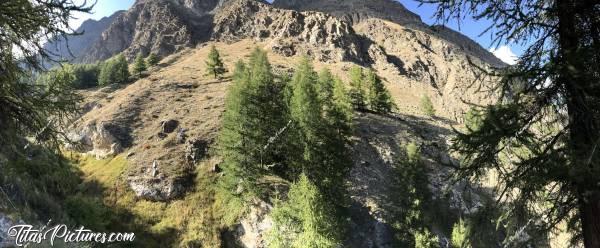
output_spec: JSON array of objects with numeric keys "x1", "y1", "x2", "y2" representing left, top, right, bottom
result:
[{"x1": 268, "y1": 174, "x2": 341, "y2": 248}]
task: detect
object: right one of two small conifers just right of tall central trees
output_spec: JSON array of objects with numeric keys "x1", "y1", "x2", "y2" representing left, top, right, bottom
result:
[{"x1": 364, "y1": 69, "x2": 395, "y2": 113}]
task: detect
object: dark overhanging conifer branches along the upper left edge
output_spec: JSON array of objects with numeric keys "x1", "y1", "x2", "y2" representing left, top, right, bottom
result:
[{"x1": 0, "y1": 0, "x2": 91, "y2": 148}]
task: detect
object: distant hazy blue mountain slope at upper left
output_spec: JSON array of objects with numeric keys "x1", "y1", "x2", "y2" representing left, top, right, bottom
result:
[{"x1": 44, "y1": 11, "x2": 125, "y2": 62}]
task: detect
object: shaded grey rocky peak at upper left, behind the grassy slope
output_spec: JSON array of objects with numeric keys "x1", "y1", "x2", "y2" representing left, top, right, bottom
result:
[{"x1": 81, "y1": 0, "x2": 230, "y2": 62}]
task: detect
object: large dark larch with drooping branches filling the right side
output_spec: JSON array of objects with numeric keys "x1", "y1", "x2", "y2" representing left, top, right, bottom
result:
[{"x1": 421, "y1": 0, "x2": 600, "y2": 245}]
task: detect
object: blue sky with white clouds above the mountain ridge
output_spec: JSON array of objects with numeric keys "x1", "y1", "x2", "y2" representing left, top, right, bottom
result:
[{"x1": 72, "y1": 0, "x2": 523, "y2": 64}]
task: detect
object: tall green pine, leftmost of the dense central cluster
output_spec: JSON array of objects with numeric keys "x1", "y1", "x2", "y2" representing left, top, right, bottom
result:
[{"x1": 219, "y1": 49, "x2": 286, "y2": 193}]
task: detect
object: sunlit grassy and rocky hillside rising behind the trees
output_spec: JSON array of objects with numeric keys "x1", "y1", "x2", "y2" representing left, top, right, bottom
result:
[{"x1": 0, "y1": 0, "x2": 552, "y2": 248}]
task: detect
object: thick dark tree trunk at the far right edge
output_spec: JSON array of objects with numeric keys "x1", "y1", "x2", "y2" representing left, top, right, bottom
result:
[{"x1": 556, "y1": 0, "x2": 600, "y2": 248}]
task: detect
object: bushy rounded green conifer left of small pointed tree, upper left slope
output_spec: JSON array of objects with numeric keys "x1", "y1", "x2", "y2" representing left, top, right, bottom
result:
[{"x1": 98, "y1": 54, "x2": 130, "y2": 86}]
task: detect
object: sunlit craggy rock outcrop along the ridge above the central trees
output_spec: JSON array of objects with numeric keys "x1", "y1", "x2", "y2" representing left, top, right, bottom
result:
[{"x1": 213, "y1": 0, "x2": 365, "y2": 62}]
